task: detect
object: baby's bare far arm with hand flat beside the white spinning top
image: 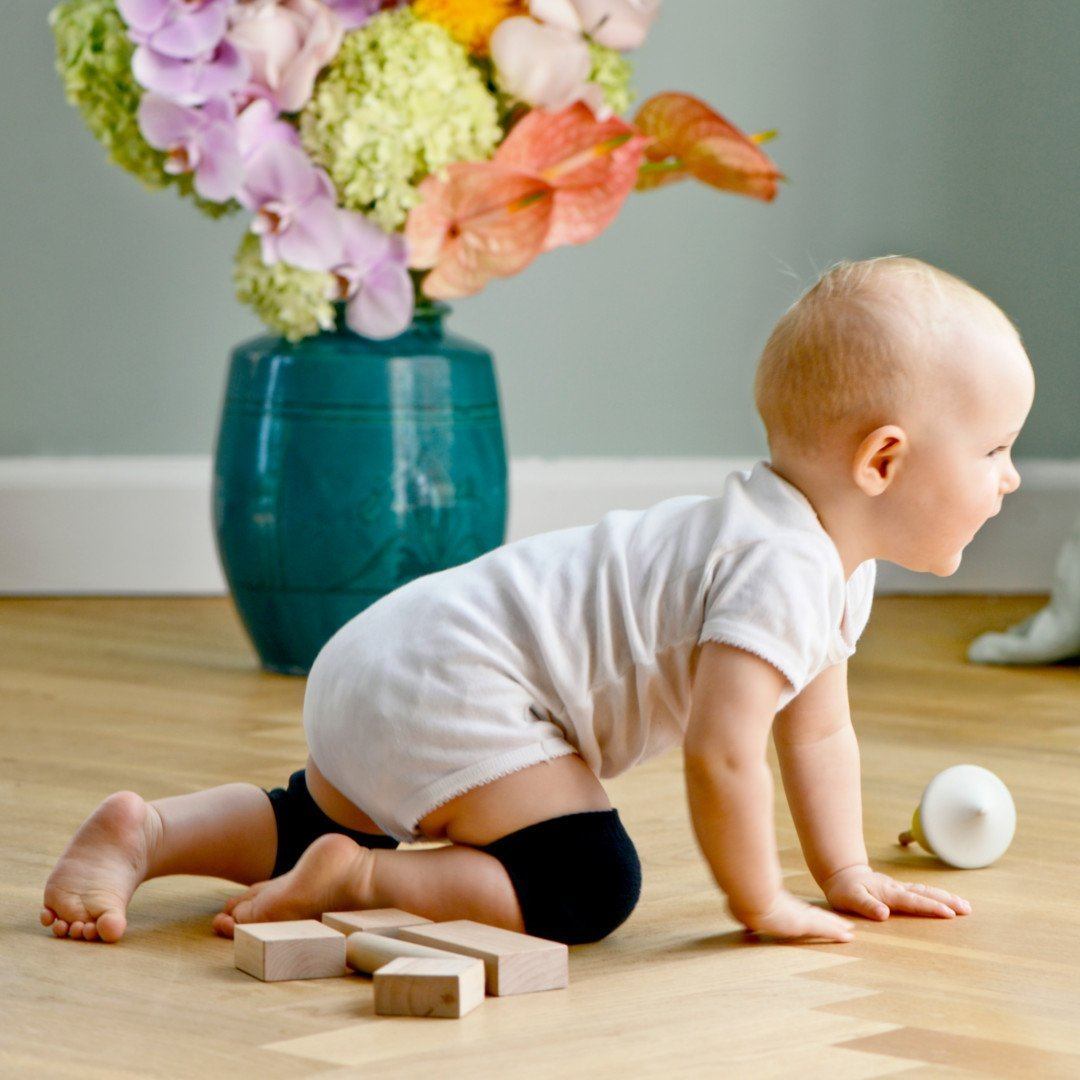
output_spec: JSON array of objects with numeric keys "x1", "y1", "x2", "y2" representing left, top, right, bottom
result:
[{"x1": 772, "y1": 661, "x2": 971, "y2": 919}]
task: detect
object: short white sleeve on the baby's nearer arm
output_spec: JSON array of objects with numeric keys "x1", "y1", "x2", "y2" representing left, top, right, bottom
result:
[{"x1": 698, "y1": 539, "x2": 835, "y2": 693}]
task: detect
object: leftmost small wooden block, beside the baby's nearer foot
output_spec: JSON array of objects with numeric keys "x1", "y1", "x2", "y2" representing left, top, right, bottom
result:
[{"x1": 233, "y1": 919, "x2": 346, "y2": 983}]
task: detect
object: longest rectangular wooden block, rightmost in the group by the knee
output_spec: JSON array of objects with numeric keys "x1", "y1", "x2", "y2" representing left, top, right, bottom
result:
[{"x1": 397, "y1": 919, "x2": 570, "y2": 997}]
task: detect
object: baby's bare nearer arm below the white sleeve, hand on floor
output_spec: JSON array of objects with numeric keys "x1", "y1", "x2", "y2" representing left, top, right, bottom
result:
[{"x1": 684, "y1": 642, "x2": 851, "y2": 941}]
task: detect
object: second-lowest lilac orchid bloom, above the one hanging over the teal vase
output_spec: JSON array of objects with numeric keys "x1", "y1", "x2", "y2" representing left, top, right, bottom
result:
[{"x1": 238, "y1": 141, "x2": 341, "y2": 270}]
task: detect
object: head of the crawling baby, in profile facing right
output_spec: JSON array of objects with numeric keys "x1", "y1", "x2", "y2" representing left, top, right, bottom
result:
[{"x1": 754, "y1": 255, "x2": 1035, "y2": 577}]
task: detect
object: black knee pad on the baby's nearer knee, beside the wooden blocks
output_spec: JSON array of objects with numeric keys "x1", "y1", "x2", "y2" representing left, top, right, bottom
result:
[{"x1": 480, "y1": 810, "x2": 642, "y2": 945}]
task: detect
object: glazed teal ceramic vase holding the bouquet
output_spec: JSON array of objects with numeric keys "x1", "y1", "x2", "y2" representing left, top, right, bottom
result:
[{"x1": 213, "y1": 303, "x2": 507, "y2": 675}]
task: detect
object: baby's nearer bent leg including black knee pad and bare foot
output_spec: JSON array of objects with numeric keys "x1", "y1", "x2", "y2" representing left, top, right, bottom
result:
[{"x1": 214, "y1": 755, "x2": 640, "y2": 941}]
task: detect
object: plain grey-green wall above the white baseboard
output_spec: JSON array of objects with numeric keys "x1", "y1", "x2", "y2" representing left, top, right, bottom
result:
[{"x1": 0, "y1": 0, "x2": 1080, "y2": 458}]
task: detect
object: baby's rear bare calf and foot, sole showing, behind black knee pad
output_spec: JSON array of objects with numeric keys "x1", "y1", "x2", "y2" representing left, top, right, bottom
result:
[{"x1": 41, "y1": 784, "x2": 278, "y2": 942}]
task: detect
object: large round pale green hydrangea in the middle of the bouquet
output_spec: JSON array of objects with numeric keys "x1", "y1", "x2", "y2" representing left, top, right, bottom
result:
[{"x1": 299, "y1": 8, "x2": 502, "y2": 230}]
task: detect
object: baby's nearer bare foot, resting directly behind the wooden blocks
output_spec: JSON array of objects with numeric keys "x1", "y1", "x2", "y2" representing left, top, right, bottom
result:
[{"x1": 214, "y1": 833, "x2": 372, "y2": 937}]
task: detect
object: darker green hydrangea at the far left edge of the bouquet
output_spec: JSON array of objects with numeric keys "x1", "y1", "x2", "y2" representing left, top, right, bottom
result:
[{"x1": 49, "y1": 0, "x2": 239, "y2": 217}]
